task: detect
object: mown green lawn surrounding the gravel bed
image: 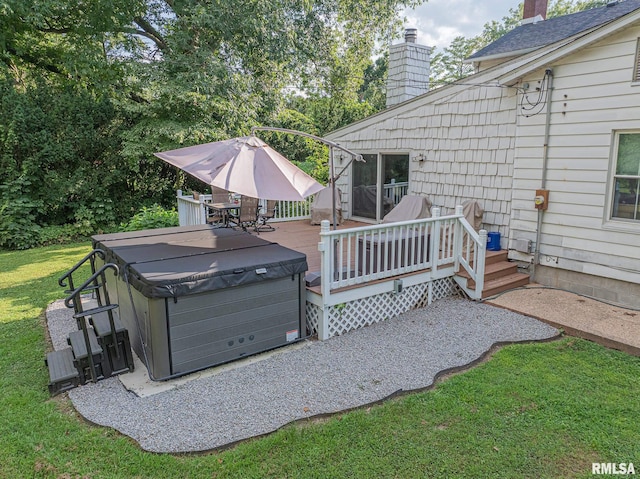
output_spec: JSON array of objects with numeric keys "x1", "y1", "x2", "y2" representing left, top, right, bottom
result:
[{"x1": 0, "y1": 244, "x2": 640, "y2": 478}]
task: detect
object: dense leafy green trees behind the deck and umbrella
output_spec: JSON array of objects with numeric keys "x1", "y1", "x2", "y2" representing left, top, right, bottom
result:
[{"x1": 0, "y1": 0, "x2": 422, "y2": 248}]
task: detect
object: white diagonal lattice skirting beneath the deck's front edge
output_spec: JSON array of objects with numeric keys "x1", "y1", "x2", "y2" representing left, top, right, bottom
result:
[{"x1": 306, "y1": 278, "x2": 459, "y2": 339}]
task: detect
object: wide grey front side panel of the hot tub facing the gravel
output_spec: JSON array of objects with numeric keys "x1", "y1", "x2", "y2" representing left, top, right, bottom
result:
[{"x1": 167, "y1": 275, "x2": 307, "y2": 375}]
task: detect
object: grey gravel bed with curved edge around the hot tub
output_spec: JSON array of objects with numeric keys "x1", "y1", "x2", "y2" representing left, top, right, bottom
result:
[{"x1": 47, "y1": 298, "x2": 558, "y2": 453}]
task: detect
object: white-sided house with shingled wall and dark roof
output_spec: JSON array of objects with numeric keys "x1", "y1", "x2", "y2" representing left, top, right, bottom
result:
[{"x1": 328, "y1": 0, "x2": 640, "y2": 308}]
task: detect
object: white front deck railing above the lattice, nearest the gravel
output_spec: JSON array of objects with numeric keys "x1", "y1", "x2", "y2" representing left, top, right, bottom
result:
[{"x1": 318, "y1": 206, "x2": 487, "y2": 304}]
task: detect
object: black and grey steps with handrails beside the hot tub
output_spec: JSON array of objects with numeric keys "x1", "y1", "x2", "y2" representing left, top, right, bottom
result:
[{"x1": 45, "y1": 255, "x2": 134, "y2": 396}]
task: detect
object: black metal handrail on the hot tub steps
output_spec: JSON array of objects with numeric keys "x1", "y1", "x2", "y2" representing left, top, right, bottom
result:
[{"x1": 64, "y1": 264, "x2": 120, "y2": 382}]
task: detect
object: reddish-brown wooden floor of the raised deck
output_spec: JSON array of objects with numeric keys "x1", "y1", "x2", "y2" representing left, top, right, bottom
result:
[{"x1": 252, "y1": 220, "x2": 369, "y2": 271}]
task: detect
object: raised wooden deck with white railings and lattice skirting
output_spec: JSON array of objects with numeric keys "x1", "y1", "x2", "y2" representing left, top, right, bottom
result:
[{"x1": 177, "y1": 199, "x2": 487, "y2": 340}]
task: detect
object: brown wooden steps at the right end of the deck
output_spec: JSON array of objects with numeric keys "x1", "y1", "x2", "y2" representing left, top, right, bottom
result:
[{"x1": 457, "y1": 250, "x2": 529, "y2": 299}]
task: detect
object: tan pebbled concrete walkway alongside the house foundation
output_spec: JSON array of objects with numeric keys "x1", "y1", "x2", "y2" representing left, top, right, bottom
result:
[{"x1": 485, "y1": 284, "x2": 640, "y2": 356}]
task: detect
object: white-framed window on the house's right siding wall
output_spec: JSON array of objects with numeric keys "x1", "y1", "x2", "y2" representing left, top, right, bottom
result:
[{"x1": 611, "y1": 133, "x2": 640, "y2": 221}]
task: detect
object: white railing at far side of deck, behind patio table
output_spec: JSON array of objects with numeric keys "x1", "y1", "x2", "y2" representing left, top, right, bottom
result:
[{"x1": 176, "y1": 190, "x2": 311, "y2": 226}]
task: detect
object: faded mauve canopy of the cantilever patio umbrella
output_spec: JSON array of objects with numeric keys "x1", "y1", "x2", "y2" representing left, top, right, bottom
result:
[{"x1": 155, "y1": 136, "x2": 324, "y2": 200}]
